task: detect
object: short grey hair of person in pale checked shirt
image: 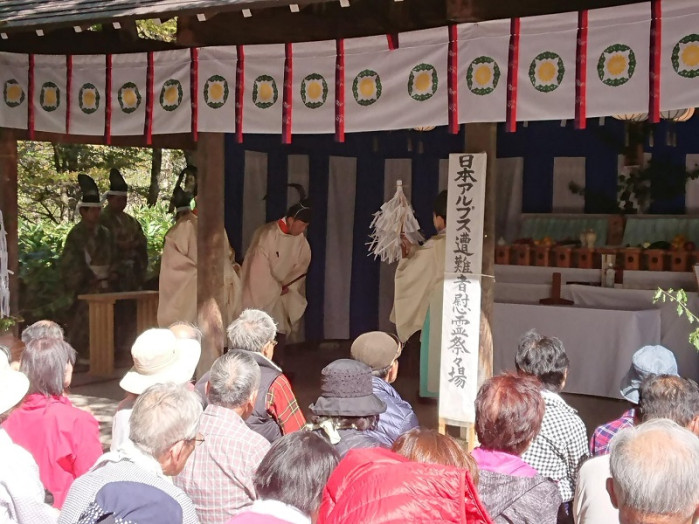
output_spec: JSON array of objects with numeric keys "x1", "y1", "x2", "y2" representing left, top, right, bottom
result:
[{"x1": 207, "y1": 350, "x2": 260, "y2": 409}]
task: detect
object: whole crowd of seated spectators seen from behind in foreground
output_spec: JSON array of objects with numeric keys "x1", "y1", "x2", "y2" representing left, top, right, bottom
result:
[{"x1": 0, "y1": 310, "x2": 699, "y2": 524}]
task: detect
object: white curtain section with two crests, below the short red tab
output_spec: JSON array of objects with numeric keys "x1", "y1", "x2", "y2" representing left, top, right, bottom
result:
[{"x1": 345, "y1": 27, "x2": 449, "y2": 132}]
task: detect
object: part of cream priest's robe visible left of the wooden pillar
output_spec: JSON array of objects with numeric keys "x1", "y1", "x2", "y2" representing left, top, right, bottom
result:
[{"x1": 158, "y1": 212, "x2": 197, "y2": 327}]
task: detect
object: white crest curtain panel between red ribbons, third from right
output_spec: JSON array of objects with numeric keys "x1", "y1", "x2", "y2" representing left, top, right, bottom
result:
[{"x1": 517, "y1": 13, "x2": 578, "y2": 121}]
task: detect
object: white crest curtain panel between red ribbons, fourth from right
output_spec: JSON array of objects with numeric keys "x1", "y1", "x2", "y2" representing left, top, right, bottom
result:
[{"x1": 458, "y1": 20, "x2": 510, "y2": 122}]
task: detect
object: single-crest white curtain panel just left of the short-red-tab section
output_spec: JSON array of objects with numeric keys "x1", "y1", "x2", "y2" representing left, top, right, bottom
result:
[{"x1": 291, "y1": 40, "x2": 335, "y2": 133}]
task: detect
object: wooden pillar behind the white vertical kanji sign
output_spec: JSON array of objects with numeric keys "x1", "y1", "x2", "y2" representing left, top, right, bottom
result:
[{"x1": 466, "y1": 123, "x2": 497, "y2": 385}]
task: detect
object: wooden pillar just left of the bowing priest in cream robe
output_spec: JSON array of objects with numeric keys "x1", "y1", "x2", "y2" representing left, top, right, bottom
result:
[{"x1": 196, "y1": 133, "x2": 226, "y2": 377}]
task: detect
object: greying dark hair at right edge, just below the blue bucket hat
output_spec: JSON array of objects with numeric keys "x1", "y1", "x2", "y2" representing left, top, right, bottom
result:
[{"x1": 636, "y1": 375, "x2": 699, "y2": 436}]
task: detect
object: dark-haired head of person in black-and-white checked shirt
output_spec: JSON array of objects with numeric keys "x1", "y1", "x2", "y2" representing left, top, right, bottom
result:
[{"x1": 515, "y1": 330, "x2": 570, "y2": 393}]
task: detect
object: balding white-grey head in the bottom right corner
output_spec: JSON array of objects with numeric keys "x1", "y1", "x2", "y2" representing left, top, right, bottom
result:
[{"x1": 610, "y1": 419, "x2": 699, "y2": 516}]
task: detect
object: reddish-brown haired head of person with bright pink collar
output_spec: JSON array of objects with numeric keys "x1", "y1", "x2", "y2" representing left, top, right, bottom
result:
[{"x1": 476, "y1": 373, "x2": 546, "y2": 455}]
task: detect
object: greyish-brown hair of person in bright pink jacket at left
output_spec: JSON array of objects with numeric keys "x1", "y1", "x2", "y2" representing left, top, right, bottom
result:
[{"x1": 20, "y1": 338, "x2": 77, "y2": 396}]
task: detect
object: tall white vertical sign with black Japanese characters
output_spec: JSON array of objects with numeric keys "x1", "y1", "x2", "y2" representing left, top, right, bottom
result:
[{"x1": 439, "y1": 153, "x2": 486, "y2": 426}]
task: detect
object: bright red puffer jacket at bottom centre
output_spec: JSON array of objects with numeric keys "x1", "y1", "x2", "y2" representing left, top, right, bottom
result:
[{"x1": 318, "y1": 448, "x2": 492, "y2": 524}]
